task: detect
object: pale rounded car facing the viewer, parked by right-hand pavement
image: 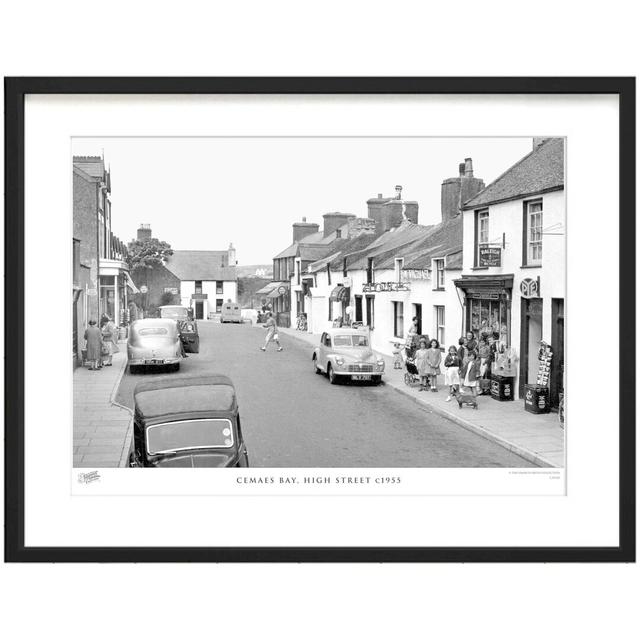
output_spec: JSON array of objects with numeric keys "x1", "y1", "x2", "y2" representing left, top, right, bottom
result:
[{"x1": 311, "y1": 327, "x2": 384, "y2": 384}]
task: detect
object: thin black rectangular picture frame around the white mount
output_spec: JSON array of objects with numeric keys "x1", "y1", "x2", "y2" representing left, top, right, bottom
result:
[{"x1": 4, "y1": 77, "x2": 636, "y2": 562}]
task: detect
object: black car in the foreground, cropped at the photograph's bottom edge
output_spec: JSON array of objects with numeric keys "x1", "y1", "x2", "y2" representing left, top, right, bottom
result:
[{"x1": 129, "y1": 374, "x2": 249, "y2": 467}]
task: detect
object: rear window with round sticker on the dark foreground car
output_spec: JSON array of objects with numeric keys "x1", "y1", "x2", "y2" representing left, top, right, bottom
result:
[{"x1": 147, "y1": 418, "x2": 233, "y2": 455}]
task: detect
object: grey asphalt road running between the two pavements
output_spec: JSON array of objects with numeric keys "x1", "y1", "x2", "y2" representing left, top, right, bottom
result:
[{"x1": 117, "y1": 321, "x2": 533, "y2": 467}]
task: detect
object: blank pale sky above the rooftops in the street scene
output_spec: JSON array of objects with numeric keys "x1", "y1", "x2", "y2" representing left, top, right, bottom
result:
[{"x1": 73, "y1": 137, "x2": 532, "y2": 264}]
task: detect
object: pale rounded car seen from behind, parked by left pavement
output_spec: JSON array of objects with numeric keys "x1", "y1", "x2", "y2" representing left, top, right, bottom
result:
[{"x1": 127, "y1": 318, "x2": 182, "y2": 373}]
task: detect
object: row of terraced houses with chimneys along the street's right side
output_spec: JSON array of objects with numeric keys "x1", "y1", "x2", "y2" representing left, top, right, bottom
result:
[{"x1": 259, "y1": 138, "x2": 566, "y2": 405}]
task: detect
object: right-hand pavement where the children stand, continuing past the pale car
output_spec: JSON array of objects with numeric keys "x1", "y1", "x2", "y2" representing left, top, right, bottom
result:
[{"x1": 278, "y1": 327, "x2": 565, "y2": 467}]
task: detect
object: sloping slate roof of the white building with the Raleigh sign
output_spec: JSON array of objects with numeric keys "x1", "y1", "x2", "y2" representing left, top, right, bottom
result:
[{"x1": 462, "y1": 138, "x2": 564, "y2": 209}]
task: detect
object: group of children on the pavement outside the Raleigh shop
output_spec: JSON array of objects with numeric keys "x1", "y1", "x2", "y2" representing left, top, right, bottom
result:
[{"x1": 415, "y1": 332, "x2": 493, "y2": 402}]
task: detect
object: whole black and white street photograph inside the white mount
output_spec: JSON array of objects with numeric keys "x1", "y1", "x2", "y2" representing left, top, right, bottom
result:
[{"x1": 69, "y1": 135, "x2": 568, "y2": 472}]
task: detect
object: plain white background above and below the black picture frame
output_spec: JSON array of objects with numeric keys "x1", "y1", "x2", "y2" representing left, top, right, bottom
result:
[{"x1": 0, "y1": 0, "x2": 640, "y2": 640}]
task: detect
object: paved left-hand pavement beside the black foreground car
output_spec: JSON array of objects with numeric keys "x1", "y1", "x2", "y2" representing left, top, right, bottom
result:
[{"x1": 73, "y1": 342, "x2": 133, "y2": 468}]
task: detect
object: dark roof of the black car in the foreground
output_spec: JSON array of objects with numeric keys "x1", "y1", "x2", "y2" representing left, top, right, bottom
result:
[{"x1": 136, "y1": 384, "x2": 235, "y2": 418}]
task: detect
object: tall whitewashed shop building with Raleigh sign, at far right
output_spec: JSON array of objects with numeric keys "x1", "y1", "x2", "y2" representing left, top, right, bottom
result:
[{"x1": 456, "y1": 138, "x2": 566, "y2": 406}]
